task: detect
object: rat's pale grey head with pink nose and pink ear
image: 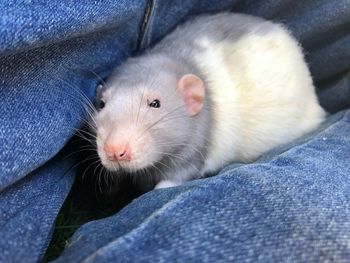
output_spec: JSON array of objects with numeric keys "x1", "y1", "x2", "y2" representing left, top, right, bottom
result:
[{"x1": 95, "y1": 65, "x2": 205, "y2": 172}]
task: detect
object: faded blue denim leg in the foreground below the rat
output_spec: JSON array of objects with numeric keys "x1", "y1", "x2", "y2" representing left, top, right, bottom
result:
[{"x1": 56, "y1": 111, "x2": 350, "y2": 262}]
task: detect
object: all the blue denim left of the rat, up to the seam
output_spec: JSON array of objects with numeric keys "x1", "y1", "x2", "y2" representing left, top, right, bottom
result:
[{"x1": 0, "y1": 0, "x2": 146, "y2": 262}]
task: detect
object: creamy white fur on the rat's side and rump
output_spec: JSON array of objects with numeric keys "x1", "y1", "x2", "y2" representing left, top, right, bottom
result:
[{"x1": 195, "y1": 22, "x2": 325, "y2": 172}]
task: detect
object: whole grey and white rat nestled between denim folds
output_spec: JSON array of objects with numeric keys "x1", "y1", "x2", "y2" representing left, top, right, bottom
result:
[{"x1": 93, "y1": 13, "x2": 326, "y2": 189}]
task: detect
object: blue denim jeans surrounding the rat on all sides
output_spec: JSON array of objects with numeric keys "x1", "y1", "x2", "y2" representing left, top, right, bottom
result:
[{"x1": 0, "y1": 0, "x2": 350, "y2": 262}]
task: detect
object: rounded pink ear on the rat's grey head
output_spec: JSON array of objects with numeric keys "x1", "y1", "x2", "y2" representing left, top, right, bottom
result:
[{"x1": 177, "y1": 74, "x2": 205, "y2": 116}]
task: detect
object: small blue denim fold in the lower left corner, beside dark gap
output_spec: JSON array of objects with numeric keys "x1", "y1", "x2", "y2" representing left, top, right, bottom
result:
[{"x1": 0, "y1": 154, "x2": 74, "y2": 262}]
